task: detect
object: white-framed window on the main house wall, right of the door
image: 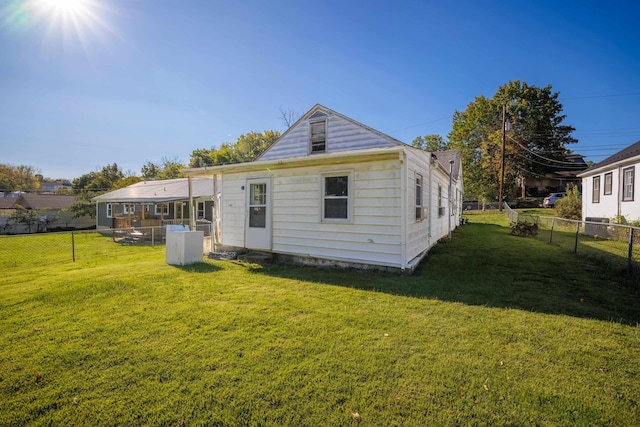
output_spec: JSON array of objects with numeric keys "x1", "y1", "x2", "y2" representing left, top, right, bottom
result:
[{"x1": 322, "y1": 172, "x2": 351, "y2": 222}]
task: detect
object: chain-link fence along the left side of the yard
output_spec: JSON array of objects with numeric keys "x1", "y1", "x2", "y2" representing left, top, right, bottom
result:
[{"x1": 0, "y1": 224, "x2": 212, "y2": 269}]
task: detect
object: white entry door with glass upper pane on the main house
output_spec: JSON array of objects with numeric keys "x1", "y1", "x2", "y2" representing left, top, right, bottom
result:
[{"x1": 244, "y1": 178, "x2": 271, "y2": 250}]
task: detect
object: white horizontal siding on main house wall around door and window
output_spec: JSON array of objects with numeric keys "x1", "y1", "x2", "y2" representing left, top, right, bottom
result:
[{"x1": 221, "y1": 160, "x2": 401, "y2": 266}]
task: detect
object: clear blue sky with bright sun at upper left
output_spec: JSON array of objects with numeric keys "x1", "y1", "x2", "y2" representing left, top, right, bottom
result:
[{"x1": 0, "y1": 0, "x2": 640, "y2": 179}]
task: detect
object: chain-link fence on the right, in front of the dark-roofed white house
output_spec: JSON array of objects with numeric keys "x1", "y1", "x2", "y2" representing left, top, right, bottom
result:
[{"x1": 504, "y1": 203, "x2": 640, "y2": 277}]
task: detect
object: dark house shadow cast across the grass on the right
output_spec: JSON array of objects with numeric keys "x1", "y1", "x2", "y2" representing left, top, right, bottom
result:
[{"x1": 249, "y1": 223, "x2": 640, "y2": 325}]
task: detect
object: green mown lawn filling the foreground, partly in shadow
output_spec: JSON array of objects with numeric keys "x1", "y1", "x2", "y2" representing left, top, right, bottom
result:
[{"x1": 0, "y1": 213, "x2": 640, "y2": 426}]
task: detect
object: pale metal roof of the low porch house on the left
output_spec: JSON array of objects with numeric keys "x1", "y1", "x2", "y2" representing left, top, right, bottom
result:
[{"x1": 91, "y1": 178, "x2": 213, "y2": 203}]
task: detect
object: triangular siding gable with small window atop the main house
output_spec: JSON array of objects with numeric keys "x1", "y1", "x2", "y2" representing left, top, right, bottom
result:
[{"x1": 256, "y1": 104, "x2": 405, "y2": 160}]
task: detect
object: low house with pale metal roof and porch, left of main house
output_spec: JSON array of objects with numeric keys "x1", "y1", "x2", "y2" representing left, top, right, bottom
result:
[{"x1": 91, "y1": 178, "x2": 214, "y2": 229}]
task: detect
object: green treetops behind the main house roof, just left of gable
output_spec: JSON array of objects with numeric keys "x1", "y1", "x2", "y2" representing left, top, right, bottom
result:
[{"x1": 189, "y1": 130, "x2": 280, "y2": 168}]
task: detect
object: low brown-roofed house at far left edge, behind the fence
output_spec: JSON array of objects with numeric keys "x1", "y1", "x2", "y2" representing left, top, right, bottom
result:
[{"x1": 0, "y1": 193, "x2": 95, "y2": 234}]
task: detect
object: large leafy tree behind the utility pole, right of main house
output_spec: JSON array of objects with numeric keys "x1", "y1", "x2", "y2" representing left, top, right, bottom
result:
[{"x1": 448, "y1": 80, "x2": 577, "y2": 201}]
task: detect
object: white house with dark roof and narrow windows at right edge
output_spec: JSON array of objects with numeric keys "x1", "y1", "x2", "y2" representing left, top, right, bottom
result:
[{"x1": 579, "y1": 141, "x2": 640, "y2": 226}]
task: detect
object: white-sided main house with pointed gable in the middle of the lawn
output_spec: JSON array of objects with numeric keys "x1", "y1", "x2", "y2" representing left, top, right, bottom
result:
[{"x1": 184, "y1": 105, "x2": 463, "y2": 271}]
